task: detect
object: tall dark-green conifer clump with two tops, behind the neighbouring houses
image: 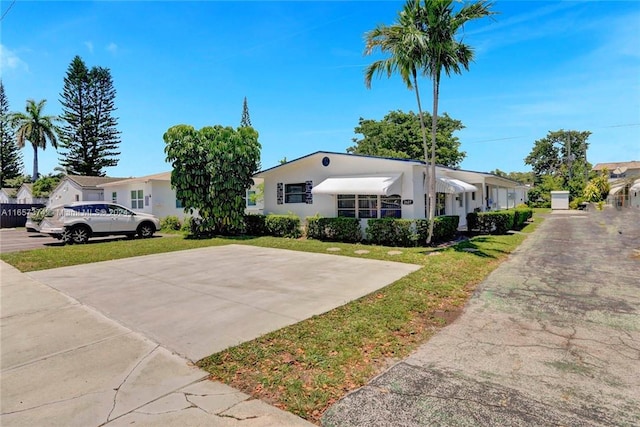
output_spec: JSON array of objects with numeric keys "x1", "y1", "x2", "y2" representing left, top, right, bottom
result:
[{"x1": 60, "y1": 56, "x2": 120, "y2": 176}]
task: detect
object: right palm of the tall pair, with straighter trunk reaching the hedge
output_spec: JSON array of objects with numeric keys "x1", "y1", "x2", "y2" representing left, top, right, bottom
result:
[{"x1": 418, "y1": 0, "x2": 495, "y2": 243}]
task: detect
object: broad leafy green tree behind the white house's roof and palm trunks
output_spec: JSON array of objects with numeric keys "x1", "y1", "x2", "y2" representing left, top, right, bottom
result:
[{"x1": 347, "y1": 110, "x2": 466, "y2": 168}]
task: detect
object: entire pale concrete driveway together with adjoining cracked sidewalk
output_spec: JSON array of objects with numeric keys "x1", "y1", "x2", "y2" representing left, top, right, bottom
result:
[{"x1": 0, "y1": 245, "x2": 419, "y2": 427}]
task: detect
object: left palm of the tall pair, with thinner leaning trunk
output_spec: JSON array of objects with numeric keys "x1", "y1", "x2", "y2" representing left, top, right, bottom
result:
[{"x1": 364, "y1": 0, "x2": 429, "y2": 191}]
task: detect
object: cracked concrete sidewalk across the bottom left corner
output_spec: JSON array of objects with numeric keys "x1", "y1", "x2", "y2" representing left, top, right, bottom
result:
[{"x1": 0, "y1": 261, "x2": 313, "y2": 427}]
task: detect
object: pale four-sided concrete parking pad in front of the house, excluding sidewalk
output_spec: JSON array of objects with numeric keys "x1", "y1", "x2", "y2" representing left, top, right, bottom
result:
[{"x1": 29, "y1": 245, "x2": 419, "y2": 361}]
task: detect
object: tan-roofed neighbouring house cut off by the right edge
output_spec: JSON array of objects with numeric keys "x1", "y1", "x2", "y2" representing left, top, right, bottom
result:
[{"x1": 593, "y1": 160, "x2": 640, "y2": 208}]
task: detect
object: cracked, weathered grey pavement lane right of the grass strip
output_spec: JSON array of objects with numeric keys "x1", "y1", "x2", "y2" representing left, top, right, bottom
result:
[{"x1": 323, "y1": 208, "x2": 640, "y2": 426}]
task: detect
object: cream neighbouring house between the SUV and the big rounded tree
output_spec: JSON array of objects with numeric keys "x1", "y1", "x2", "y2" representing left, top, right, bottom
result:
[{"x1": 102, "y1": 172, "x2": 186, "y2": 219}]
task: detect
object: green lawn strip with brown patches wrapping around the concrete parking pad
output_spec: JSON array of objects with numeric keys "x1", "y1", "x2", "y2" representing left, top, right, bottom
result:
[{"x1": 0, "y1": 217, "x2": 539, "y2": 423}]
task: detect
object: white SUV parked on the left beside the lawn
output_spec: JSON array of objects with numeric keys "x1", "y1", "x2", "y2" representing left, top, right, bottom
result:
[{"x1": 39, "y1": 202, "x2": 160, "y2": 244}]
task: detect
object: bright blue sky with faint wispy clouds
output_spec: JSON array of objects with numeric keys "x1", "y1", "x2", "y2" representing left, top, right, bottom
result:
[{"x1": 0, "y1": 0, "x2": 640, "y2": 176}]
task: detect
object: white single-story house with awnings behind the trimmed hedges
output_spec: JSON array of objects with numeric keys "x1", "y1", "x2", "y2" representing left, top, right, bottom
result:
[{"x1": 254, "y1": 151, "x2": 527, "y2": 227}]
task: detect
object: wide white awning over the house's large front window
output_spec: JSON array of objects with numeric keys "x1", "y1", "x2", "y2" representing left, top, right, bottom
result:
[{"x1": 311, "y1": 173, "x2": 402, "y2": 196}]
